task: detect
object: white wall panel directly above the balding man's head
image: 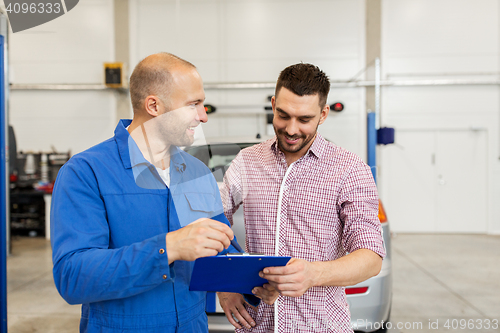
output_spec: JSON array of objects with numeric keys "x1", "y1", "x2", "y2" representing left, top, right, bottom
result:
[{"x1": 130, "y1": 0, "x2": 222, "y2": 81}]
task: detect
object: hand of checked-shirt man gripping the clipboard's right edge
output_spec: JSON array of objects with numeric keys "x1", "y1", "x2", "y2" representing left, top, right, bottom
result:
[{"x1": 259, "y1": 258, "x2": 321, "y2": 297}]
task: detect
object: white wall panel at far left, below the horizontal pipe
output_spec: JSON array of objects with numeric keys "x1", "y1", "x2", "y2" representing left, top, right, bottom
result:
[{"x1": 10, "y1": 91, "x2": 116, "y2": 154}]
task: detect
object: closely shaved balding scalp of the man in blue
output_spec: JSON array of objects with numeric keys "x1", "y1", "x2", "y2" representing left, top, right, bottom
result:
[{"x1": 129, "y1": 52, "x2": 196, "y2": 112}]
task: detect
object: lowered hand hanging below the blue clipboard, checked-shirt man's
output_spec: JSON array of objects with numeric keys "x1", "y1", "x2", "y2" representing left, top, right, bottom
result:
[{"x1": 217, "y1": 292, "x2": 257, "y2": 329}]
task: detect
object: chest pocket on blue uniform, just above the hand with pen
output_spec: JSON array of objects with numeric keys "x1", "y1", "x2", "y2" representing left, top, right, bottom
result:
[{"x1": 173, "y1": 192, "x2": 216, "y2": 227}]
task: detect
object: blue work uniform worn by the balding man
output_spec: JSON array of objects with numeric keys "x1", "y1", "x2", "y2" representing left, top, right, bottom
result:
[{"x1": 50, "y1": 120, "x2": 236, "y2": 333}]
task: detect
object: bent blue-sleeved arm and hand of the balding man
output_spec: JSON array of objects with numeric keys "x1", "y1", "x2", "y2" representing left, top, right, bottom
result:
[{"x1": 51, "y1": 159, "x2": 232, "y2": 304}]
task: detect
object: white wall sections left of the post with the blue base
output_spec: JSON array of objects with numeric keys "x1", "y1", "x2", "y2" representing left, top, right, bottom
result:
[{"x1": 9, "y1": 0, "x2": 366, "y2": 157}]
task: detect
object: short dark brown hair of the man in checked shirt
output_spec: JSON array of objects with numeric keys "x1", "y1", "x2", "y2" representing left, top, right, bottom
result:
[{"x1": 274, "y1": 63, "x2": 330, "y2": 108}]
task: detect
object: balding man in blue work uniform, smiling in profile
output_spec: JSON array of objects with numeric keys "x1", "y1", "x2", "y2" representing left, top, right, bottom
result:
[{"x1": 51, "y1": 53, "x2": 240, "y2": 333}]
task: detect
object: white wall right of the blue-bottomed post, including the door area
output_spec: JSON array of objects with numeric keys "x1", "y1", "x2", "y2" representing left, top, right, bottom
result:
[{"x1": 379, "y1": 0, "x2": 500, "y2": 233}]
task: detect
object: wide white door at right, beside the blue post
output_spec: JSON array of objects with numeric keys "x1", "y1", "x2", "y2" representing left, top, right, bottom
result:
[{"x1": 379, "y1": 130, "x2": 488, "y2": 233}]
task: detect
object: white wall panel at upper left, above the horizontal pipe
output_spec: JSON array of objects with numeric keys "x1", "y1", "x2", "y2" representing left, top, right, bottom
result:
[{"x1": 9, "y1": 0, "x2": 114, "y2": 83}]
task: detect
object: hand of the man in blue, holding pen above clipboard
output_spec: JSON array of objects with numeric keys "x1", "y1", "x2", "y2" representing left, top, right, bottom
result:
[{"x1": 166, "y1": 218, "x2": 234, "y2": 264}]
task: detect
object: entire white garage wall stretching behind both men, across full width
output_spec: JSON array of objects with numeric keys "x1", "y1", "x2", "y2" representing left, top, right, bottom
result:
[{"x1": 3, "y1": 0, "x2": 500, "y2": 234}]
